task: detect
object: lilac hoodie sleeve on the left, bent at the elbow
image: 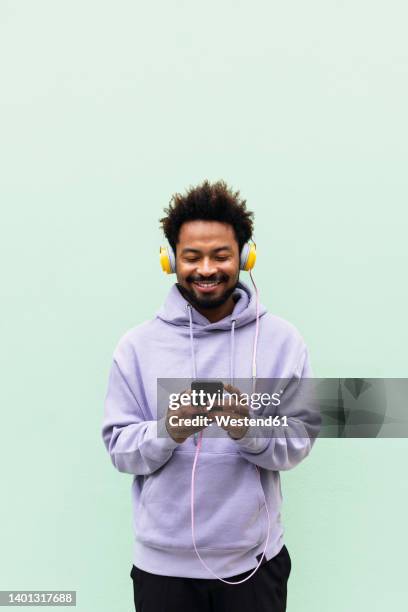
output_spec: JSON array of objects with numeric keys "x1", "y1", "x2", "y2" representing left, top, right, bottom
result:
[{"x1": 102, "y1": 359, "x2": 178, "y2": 475}]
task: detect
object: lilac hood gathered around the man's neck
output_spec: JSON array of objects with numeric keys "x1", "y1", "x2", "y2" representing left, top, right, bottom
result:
[{"x1": 156, "y1": 281, "x2": 267, "y2": 337}]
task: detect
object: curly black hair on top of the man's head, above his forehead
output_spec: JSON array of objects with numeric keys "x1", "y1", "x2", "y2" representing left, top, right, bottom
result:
[{"x1": 160, "y1": 180, "x2": 254, "y2": 252}]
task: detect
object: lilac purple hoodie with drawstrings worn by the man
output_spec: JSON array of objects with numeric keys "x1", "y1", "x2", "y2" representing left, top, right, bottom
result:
[{"x1": 102, "y1": 282, "x2": 315, "y2": 578}]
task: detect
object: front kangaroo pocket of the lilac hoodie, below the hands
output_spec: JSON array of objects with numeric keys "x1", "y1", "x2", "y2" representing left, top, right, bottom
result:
[{"x1": 135, "y1": 451, "x2": 267, "y2": 551}]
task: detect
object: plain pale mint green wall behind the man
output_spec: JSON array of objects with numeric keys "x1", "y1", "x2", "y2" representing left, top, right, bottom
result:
[{"x1": 0, "y1": 0, "x2": 408, "y2": 612}]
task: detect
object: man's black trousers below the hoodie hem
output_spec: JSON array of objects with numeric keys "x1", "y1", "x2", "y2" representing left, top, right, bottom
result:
[{"x1": 130, "y1": 545, "x2": 292, "y2": 612}]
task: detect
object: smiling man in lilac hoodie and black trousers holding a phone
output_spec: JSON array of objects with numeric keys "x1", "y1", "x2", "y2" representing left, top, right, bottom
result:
[{"x1": 102, "y1": 181, "x2": 316, "y2": 612}]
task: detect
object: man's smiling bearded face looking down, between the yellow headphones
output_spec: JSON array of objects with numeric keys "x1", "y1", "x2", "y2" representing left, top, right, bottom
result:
[{"x1": 176, "y1": 220, "x2": 239, "y2": 309}]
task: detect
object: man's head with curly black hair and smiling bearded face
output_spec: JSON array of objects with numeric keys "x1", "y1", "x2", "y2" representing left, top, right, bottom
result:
[{"x1": 160, "y1": 180, "x2": 253, "y2": 310}]
